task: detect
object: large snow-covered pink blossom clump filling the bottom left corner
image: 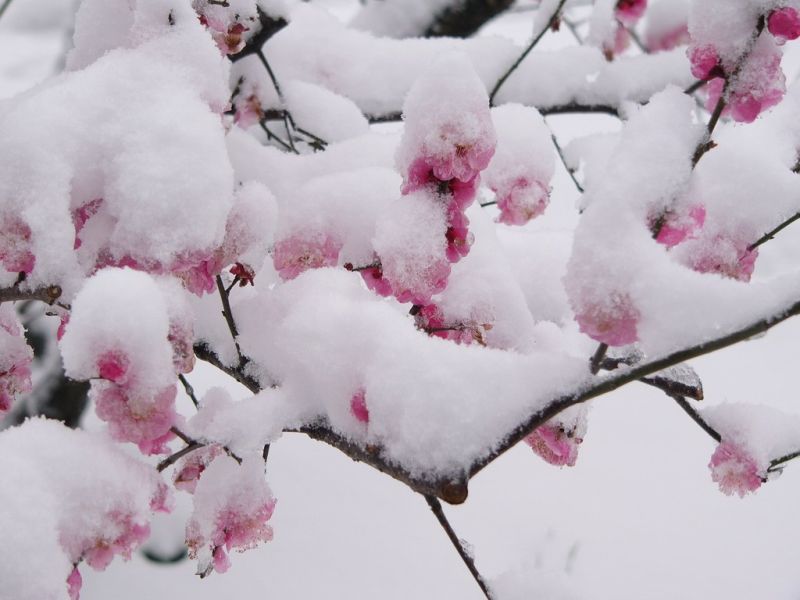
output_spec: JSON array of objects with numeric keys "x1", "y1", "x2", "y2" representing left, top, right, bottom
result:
[{"x1": 0, "y1": 419, "x2": 169, "y2": 600}]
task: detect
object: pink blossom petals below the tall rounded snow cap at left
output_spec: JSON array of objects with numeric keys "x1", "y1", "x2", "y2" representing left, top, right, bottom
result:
[{"x1": 92, "y1": 382, "x2": 176, "y2": 454}]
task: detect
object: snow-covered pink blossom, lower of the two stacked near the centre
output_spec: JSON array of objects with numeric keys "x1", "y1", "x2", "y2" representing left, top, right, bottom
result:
[{"x1": 373, "y1": 190, "x2": 450, "y2": 304}]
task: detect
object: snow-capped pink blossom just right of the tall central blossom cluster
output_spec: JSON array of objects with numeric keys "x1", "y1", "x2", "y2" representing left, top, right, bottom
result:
[{"x1": 485, "y1": 104, "x2": 555, "y2": 225}]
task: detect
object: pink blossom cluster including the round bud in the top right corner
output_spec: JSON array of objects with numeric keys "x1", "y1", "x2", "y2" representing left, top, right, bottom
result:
[{"x1": 687, "y1": 7, "x2": 800, "y2": 123}]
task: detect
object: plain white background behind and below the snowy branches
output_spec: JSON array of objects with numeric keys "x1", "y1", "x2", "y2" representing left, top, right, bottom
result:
[{"x1": 0, "y1": 0, "x2": 800, "y2": 600}]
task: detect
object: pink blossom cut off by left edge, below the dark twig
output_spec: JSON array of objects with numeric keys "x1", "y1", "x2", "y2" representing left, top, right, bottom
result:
[{"x1": 0, "y1": 304, "x2": 33, "y2": 415}]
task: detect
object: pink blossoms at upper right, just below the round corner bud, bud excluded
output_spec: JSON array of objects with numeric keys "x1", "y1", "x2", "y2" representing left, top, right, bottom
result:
[{"x1": 688, "y1": 37, "x2": 786, "y2": 123}]
